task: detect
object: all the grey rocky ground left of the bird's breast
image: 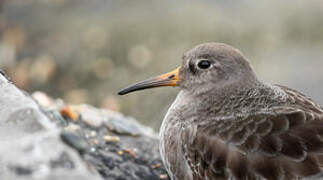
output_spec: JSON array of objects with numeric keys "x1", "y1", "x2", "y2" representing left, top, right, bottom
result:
[{"x1": 0, "y1": 73, "x2": 169, "y2": 180}]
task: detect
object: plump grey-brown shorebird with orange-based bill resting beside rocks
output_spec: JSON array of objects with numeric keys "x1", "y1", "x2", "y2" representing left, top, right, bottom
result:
[{"x1": 118, "y1": 42, "x2": 323, "y2": 180}]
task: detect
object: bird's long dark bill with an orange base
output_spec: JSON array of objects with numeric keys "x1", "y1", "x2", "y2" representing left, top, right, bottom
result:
[{"x1": 118, "y1": 68, "x2": 180, "y2": 95}]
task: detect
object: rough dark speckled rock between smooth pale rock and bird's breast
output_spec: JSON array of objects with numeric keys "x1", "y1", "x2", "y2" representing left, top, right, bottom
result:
[{"x1": 58, "y1": 105, "x2": 168, "y2": 180}]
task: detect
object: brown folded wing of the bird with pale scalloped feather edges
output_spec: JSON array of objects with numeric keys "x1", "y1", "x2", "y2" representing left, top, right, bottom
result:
[{"x1": 181, "y1": 89, "x2": 323, "y2": 180}]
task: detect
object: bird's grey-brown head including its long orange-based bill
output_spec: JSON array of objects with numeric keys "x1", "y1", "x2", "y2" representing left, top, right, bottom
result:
[{"x1": 119, "y1": 43, "x2": 256, "y2": 95}]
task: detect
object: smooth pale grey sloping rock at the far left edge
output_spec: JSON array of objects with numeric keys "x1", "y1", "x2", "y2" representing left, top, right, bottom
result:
[{"x1": 0, "y1": 74, "x2": 102, "y2": 180}]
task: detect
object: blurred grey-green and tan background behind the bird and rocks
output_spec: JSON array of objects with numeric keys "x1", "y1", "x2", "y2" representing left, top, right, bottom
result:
[{"x1": 0, "y1": 0, "x2": 323, "y2": 129}]
